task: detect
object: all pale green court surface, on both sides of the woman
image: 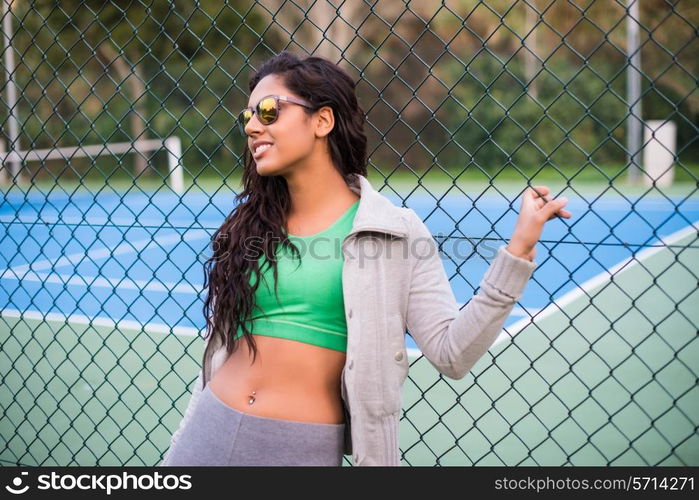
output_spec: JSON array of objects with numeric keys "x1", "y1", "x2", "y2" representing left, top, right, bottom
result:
[{"x1": 0, "y1": 232, "x2": 699, "y2": 466}]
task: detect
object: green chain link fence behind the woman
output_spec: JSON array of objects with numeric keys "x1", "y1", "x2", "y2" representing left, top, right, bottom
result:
[{"x1": 0, "y1": 0, "x2": 699, "y2": 465}]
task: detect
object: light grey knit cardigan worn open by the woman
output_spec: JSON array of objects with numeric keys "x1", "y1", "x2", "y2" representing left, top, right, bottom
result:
[{"x1": 160, "y1": 175, "x2": 536, "y2": 466}]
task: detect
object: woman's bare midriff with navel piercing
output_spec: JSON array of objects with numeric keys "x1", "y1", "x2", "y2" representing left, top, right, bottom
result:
[{"x1": 209, "y1": 335, "x2": 346, "y2": 424}]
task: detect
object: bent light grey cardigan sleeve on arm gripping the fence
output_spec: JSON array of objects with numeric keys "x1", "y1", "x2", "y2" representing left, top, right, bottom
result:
[{"x1": 406, "y1": 209, "x2": 536, "y2": 380}]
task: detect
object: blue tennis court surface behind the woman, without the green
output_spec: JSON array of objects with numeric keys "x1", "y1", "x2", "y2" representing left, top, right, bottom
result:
[{"x1": 0, "y1": 188, "x2": 699, "y2": 348}]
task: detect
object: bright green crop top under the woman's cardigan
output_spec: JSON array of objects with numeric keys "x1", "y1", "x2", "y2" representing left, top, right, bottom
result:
[{"x1": 235, "y1": 200, "x2": 359, "y2": 352}]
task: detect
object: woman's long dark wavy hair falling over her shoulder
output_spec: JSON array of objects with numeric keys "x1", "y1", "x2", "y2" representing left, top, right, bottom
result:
[{"x1": 202, "y1": 51, "x2": 367, "y2": 383}]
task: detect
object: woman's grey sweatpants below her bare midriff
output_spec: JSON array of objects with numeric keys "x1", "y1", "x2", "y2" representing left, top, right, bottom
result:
[{"x1": 161, "y1": 384, "x2": 345, "y2": 466}]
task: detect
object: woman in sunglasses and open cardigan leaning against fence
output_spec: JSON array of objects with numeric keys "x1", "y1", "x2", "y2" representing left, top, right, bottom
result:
[{"x1": 162, "y1": 51, "x2": 571, "y2": 466}]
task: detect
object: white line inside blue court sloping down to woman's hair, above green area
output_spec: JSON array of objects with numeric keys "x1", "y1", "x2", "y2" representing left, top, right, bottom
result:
[{"x1": 0, "y1": 270, "x2": 199, "y2": 295}]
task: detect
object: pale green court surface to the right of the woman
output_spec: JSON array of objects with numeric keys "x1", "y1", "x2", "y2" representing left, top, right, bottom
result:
[{"x1": 400, "y1": 231, "x2": 699, "y2": 465}]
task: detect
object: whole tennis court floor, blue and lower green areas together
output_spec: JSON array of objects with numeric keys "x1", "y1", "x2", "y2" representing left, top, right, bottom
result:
[{"x1": 0, "y1": 190, "x2": 699, "y2": 465}]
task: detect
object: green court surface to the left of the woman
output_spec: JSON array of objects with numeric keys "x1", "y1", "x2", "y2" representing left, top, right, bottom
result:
[{"x1": 0, "y1": 316, "x2": 203, "y2": 466}]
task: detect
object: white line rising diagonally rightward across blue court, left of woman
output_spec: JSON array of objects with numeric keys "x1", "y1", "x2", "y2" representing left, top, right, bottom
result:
[{"x1": 2, "y1": 229, "x2": 209, "y2": 277}]
